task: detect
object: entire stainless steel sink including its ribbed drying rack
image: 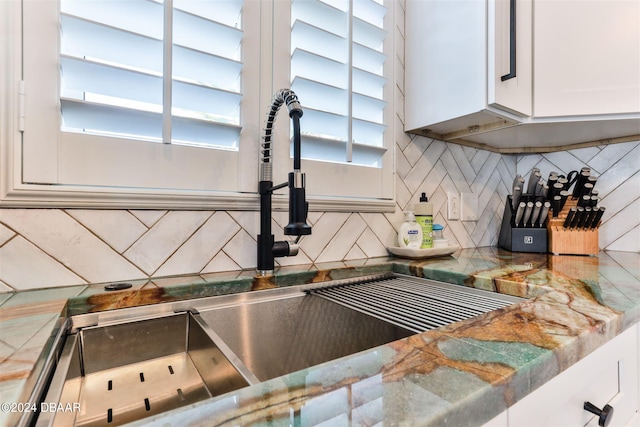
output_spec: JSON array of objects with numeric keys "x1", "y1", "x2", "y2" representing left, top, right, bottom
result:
[{"x1": 37, "y1": 274, "x2": 522, "y2": 426}]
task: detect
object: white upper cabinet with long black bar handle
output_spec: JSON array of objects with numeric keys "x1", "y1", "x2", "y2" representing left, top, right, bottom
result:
[{"x1": 405, "y1": 0, "x2": 640, "y2": 152}]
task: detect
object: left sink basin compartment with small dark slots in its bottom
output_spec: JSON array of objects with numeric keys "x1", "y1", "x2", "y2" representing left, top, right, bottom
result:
[{"x1": 37, "y1": 313, "x2": 256, "y2": 426}]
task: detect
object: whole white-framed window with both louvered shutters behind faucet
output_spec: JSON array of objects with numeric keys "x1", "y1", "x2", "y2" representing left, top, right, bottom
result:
[{"x1": 0, "y1": 0, "x2": 395, "y2": 211}]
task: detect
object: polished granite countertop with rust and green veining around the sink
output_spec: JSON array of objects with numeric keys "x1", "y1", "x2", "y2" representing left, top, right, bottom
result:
[{"x1": 0, "y1": 248, "x2": 640, "y2": 426}]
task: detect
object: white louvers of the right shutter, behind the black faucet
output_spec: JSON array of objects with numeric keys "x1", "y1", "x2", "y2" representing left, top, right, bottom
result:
[{"x1": 291, "y1": 0, "x2": 387, "y2": 167}]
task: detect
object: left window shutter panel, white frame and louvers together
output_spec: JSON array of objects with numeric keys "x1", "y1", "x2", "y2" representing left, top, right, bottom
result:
[{"x1": 22, "y1": 0, "x2": 260, "y2": 199}]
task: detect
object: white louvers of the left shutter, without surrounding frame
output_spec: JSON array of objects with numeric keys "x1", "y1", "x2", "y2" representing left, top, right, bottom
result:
[{"x1": 60, "y1": 0, "x2": 242, "y2": 149}]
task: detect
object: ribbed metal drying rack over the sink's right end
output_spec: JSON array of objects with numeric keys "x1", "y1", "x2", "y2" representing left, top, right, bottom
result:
[{"x1": 308, "y1": 276, "x2": 524, "y2": 333}]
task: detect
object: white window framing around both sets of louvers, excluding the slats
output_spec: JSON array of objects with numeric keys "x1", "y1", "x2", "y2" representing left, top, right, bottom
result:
[{"x1": 0, "y1": 0, "x2": 395, "y2": 212}]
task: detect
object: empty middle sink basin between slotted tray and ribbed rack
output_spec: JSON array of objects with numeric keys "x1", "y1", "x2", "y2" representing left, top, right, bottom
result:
[{"x1": 200, "y1": 292, "x2": 413, "y2": 381}]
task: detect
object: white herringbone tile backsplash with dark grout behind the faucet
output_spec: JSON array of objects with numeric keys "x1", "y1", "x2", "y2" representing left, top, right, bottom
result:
[{"x1": 0, "y1": 136, "x2": 640, "y2": 291}]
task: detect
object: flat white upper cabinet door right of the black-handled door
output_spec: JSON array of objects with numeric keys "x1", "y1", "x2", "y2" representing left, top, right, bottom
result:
[{"x1": 534, "y1": 0, "x2": 640, "y2": 117}]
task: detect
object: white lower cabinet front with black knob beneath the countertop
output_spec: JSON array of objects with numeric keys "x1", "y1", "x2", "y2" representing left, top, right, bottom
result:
[{"x1": 508, "y1": 325, "x2": 639, "y2": 427}]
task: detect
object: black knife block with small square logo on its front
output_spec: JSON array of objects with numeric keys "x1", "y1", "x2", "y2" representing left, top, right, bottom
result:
[{"x1": 498, "y1": 194, "x2": 547, "y2": 253}]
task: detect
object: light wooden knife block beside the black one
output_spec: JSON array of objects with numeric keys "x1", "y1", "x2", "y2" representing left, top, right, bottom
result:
[{"x1": 547, "y1": 197, "x2": 599, "y2": 255}]
